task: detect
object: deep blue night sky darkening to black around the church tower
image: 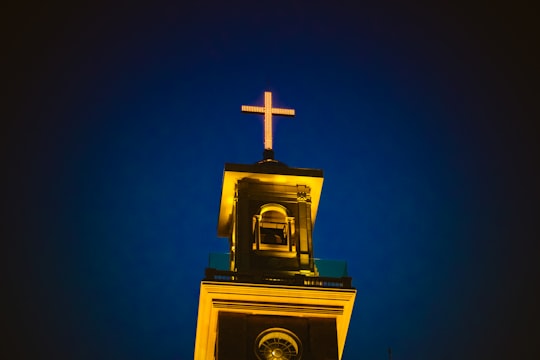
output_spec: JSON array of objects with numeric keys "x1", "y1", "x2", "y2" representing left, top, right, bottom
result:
[{"x1": 5, "y1": 1, "x2": 540, "y2": 360}]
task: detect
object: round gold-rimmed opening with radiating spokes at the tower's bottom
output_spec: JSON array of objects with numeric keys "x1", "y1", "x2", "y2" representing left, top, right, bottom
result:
[{"x1": 255, "y1": 328, "x2": 302, "y2": 360}]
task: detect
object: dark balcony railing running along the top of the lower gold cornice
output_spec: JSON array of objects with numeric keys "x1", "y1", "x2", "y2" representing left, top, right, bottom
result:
[{"x1": 205, "y1": 268, "x2": 352, "y2": 289}]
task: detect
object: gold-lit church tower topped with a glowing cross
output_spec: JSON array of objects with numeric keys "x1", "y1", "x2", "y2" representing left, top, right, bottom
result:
[{"x1": 195, "y1": 92, "x2": 356, "y2": 360}]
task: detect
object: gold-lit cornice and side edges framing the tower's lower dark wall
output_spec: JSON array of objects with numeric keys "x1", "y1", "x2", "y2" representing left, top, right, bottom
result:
[{"x1": 195, "y1": 281, "x2": 356, "y2": 360}]
